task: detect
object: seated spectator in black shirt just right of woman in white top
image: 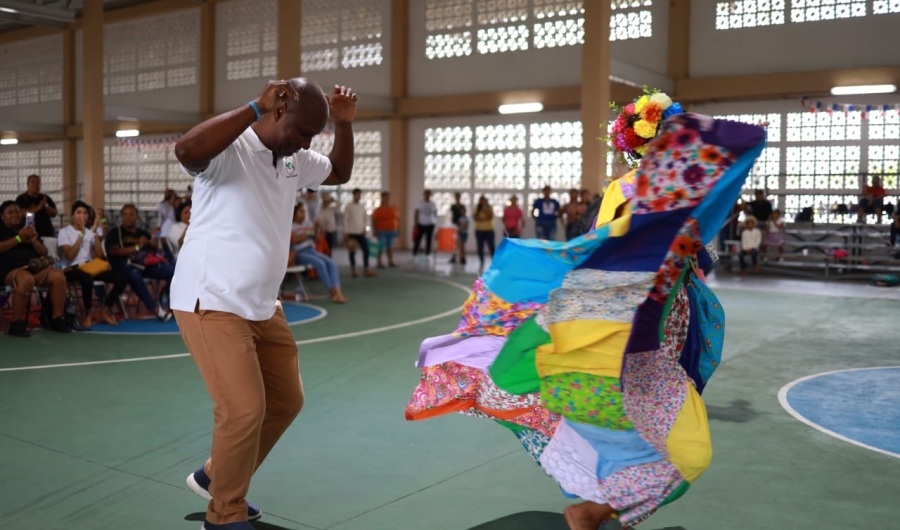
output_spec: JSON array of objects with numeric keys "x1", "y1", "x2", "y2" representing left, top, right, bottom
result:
[{"x1": 106, "y1": 204, "x2": 175, "y2": 322}]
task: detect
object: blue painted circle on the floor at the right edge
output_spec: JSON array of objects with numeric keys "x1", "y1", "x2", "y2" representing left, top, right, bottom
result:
[{"x1": 786, "y1": 367, "x2": 900, "y2": 457}]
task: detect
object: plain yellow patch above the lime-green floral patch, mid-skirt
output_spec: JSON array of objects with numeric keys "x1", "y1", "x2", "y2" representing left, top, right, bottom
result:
[{"x1": 535, "y1": 320, "x2": 631, "y2": 377}]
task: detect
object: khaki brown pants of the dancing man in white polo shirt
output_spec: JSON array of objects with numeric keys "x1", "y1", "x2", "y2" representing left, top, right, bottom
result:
[{"x1": 175, "y1": 305, "x2": 303, "y2": 524}]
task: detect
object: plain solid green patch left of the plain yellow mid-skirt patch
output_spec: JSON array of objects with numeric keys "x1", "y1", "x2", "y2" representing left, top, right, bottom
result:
[{"x1": 490, "y1": 316, "x2": 550, "y2": 395}]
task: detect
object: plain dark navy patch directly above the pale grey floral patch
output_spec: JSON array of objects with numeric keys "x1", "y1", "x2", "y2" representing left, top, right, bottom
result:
[{"x1": 577, "y1": 208, "x2": 693, "y2": 272}]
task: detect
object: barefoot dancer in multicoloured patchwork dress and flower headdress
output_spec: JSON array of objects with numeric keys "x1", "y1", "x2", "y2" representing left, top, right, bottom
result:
[{"x1": 406, "y1": 88, "x2": 765, "y2": 530}]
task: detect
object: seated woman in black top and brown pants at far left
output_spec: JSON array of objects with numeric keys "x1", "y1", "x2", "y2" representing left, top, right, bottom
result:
[{"x1": 0, "y1": 201, "x2": 72, "y2": 337}]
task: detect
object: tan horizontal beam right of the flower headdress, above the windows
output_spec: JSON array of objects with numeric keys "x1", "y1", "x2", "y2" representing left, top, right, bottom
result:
[{"x1": 675, "y1": 66, "x2": 900, "y2": 103}]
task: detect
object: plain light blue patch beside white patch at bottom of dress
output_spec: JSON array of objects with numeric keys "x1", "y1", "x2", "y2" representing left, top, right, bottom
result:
[{"x1": 563, "y1": 420, "x2": 663, "y2": 478}]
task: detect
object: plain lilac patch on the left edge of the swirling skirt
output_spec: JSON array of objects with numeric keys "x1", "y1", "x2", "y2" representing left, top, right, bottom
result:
[{"x1": 416, "y1": 335, "x2": 506, "y2": 372}]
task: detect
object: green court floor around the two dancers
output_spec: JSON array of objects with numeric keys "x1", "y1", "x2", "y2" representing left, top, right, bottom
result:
[{"x1": 0, "y1": 271, "x2": 900, "y2": 530}]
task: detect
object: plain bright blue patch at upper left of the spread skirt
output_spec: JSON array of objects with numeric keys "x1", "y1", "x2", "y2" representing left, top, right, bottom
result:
[{"x1": 482, "y1": 226, "x2": 609, "y2": 303}]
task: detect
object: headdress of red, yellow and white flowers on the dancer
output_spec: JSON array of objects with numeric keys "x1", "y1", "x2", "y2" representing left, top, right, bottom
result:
[{"x1": 606, "y1": 86, "x2": 684, "y2": 167}]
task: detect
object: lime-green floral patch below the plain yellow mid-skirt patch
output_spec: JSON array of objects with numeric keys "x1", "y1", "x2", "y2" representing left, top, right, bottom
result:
[{"x1": 541, "y1": 372, "x2": 634, "y2": 431}]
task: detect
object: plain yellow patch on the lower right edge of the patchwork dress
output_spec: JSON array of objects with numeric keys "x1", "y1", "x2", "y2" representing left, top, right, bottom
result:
[{"x1": 666, "y1": 382, "x2": 712, "y2": 482}]
